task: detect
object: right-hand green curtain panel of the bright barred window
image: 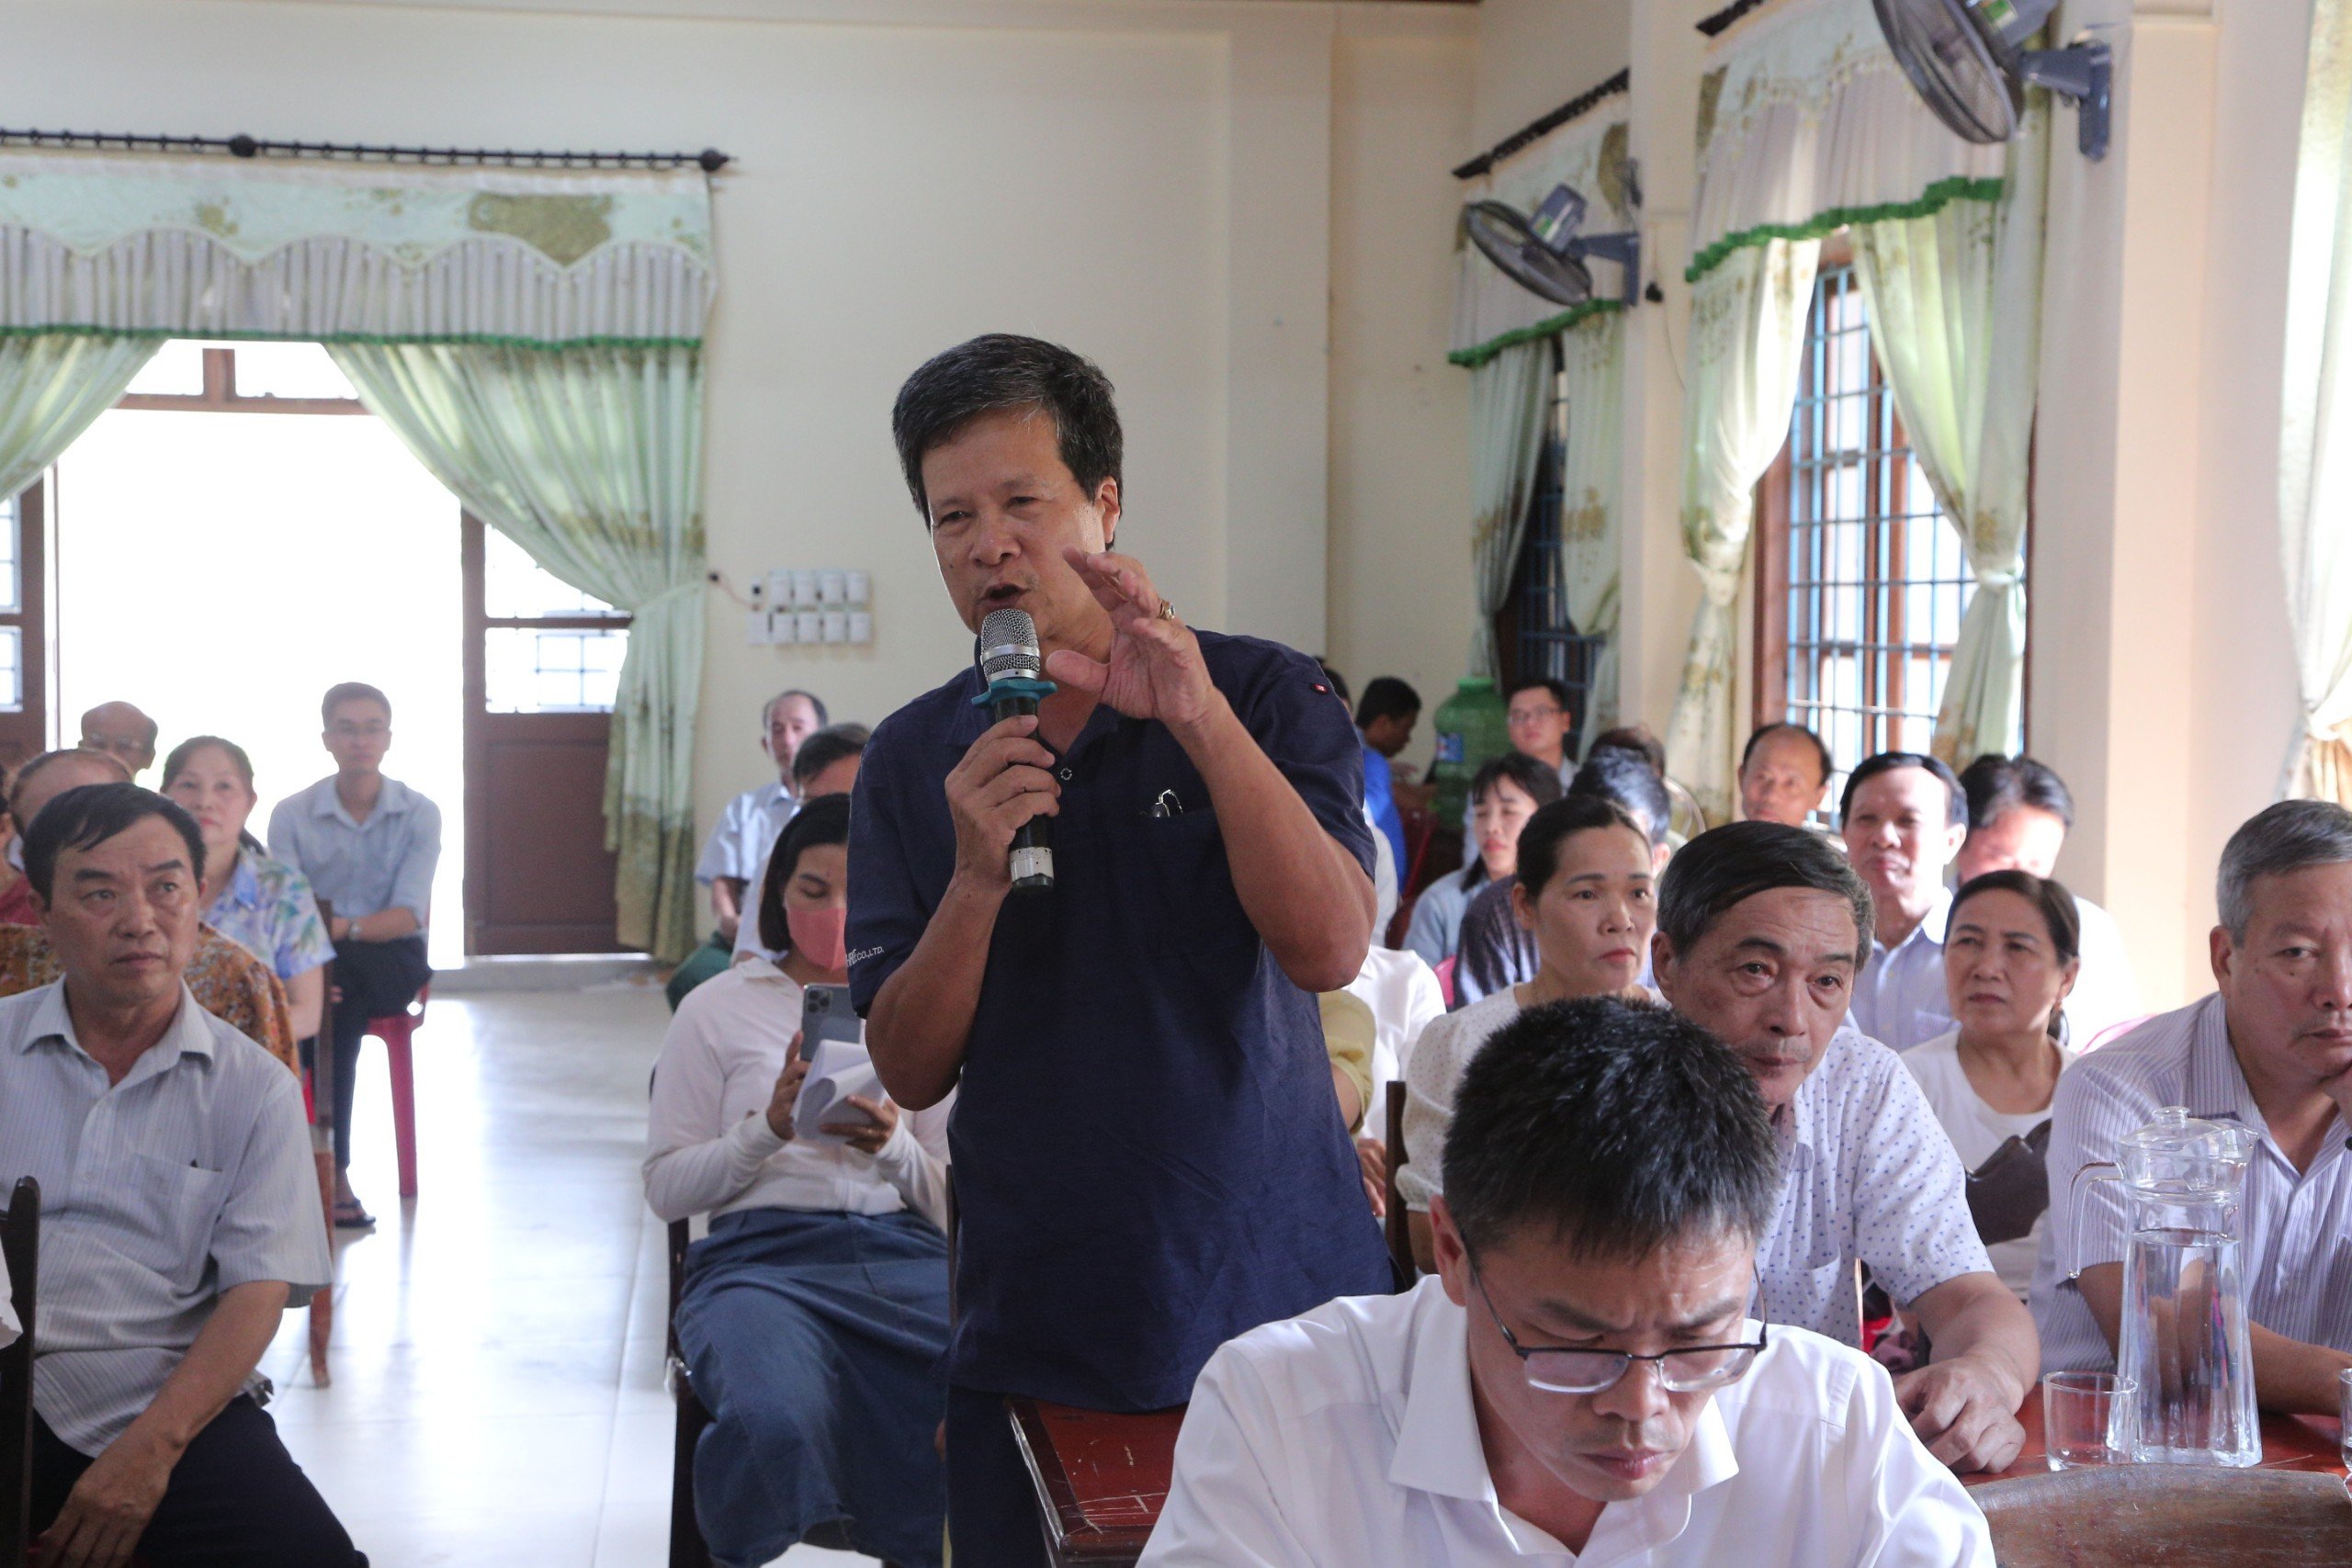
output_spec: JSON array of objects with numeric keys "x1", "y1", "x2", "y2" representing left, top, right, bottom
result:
[{"x1": 1853, "y1": 106, "x2": 2049, "y2": 769}]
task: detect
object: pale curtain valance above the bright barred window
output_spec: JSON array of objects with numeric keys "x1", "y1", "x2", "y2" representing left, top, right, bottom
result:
[{"x1": 1687, "y1": 0, "x2": 2004, "y2": 282}]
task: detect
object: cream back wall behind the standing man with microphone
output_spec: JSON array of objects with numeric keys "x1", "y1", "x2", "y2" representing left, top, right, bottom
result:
[{"x1": 0, "y1": 0, "x2": 1477, "y2": 893}]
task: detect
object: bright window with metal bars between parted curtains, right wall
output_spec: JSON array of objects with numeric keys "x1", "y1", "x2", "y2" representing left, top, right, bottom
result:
[{"x1": 1757, "y1": 261, "x2": 1975, "y2": 799}]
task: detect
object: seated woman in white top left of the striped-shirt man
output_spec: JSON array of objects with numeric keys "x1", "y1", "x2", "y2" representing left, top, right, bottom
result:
[{"x1": 1903, "y1": 872, "x2": 2082, "y2": 1300}]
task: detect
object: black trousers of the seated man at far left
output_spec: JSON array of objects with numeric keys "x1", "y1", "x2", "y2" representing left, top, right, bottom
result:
[{"x1": 33, "y1": 1396, "x2": 367, "y2": 1568}]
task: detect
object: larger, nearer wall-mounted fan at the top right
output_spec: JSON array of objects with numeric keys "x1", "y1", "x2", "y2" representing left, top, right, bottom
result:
[{"x1": 1870, "y1": 0, "x2": 2114, "y2": 160}]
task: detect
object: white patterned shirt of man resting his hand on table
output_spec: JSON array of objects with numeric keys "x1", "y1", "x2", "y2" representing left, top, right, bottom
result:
[{"x1": 1757, "y1": 1025, "x2": 1992, "y2": 1345}]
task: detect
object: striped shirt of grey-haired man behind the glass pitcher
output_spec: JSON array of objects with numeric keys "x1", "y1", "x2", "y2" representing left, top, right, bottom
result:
[{"x1": 2032, "y1": 995, "x2": 2352, "y2": 1371}]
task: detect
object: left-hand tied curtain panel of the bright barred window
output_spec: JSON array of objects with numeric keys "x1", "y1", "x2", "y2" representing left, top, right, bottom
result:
[{"x1": 1665, "y1": 240, "x2": 1820, "y2": 823}]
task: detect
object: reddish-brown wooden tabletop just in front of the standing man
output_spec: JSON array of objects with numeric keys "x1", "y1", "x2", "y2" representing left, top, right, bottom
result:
[{"x1": 1004, "y1": 1399, "x2": 1183, "y2": 1568}]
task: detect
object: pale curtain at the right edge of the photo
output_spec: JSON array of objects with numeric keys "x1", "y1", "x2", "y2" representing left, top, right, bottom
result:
[{"x1": 2279, "y1": 0, "x2": 2352, "y2": 807}]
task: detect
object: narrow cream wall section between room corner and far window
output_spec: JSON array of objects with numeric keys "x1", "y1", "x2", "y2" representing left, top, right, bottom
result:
[{"x1": 1329, "y1": 15, "x2": 1475, "y2": 764}]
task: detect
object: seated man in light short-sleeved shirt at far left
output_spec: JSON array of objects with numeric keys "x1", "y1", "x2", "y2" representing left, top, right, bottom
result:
[{"x1": 0, "y1": 783, "x2": 365, "y2": 1568}]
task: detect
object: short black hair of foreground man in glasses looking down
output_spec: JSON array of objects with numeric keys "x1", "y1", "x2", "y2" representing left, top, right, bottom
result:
[{"x1": 1444, "y1": 997, "x2": 1781, "y2": 1262}]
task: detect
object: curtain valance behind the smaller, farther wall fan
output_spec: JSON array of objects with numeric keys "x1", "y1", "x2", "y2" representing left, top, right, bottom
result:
[{"x1": 1449, "y1": 101, "x2": 1634, "y2": 367}]
